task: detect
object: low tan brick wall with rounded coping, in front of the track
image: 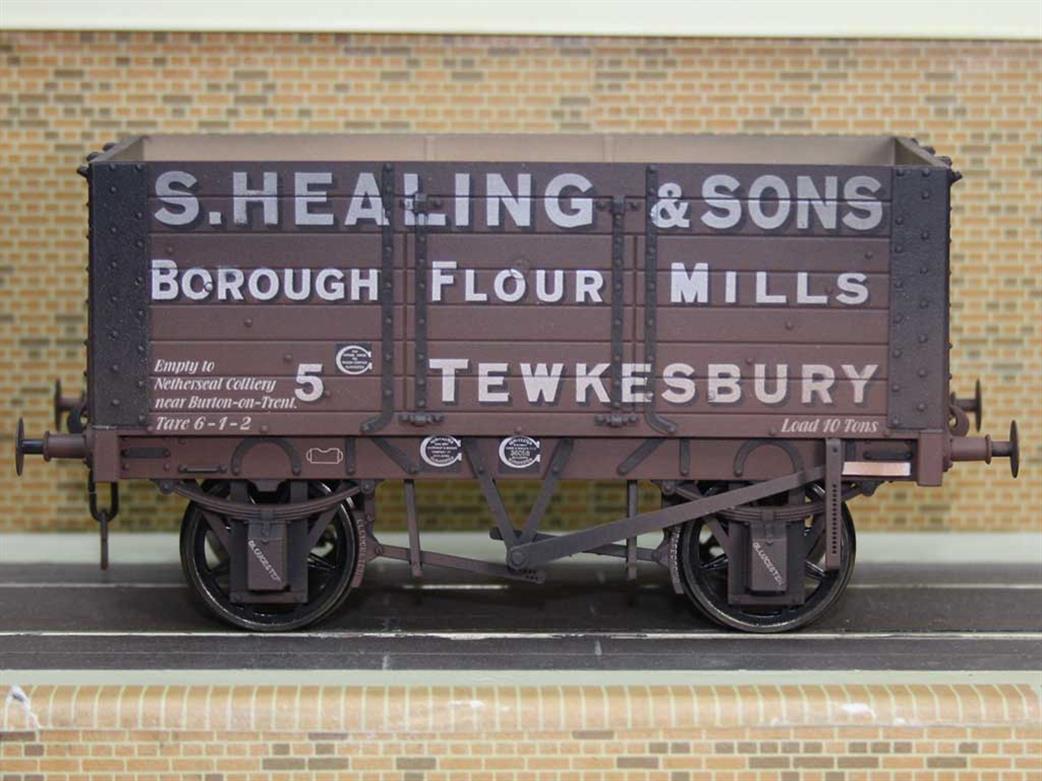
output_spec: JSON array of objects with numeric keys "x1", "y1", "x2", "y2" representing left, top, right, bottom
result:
[{"x1": 0, "y1": 684, "x2": 1042, "y2": 781}]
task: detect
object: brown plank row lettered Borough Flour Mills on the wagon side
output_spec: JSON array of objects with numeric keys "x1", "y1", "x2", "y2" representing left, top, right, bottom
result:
[{"x1": 144, "y1": 250, "x2": 890, "y2": 309}]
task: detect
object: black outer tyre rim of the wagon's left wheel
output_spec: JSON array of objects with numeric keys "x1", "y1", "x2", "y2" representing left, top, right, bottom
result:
[{"x1": 180, "y1": 481, "x2": 359, "y2": 632}]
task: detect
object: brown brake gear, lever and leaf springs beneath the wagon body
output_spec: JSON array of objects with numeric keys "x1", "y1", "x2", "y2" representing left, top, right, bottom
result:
[{"x1": 157, "y1": 438, "x2": 862, "y2": 595}]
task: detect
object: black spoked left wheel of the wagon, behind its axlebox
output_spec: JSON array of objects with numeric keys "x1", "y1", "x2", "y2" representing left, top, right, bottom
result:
[{"x1": 180, "y1": 481, "x2": 358, "y2": 632}]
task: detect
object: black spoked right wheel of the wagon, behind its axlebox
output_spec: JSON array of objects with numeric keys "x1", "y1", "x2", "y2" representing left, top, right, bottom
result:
[{"x1": 675, "y1": 485, "x2": 857, "y2": 633}]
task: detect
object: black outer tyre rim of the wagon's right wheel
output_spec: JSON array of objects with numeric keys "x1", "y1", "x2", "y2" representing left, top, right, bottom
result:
[{"x1": 674, "y1": 503, "x2": 857, "y2": 634}]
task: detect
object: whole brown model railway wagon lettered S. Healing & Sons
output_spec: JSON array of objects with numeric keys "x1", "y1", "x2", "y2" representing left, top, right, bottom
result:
[{"x1": 16, "y1": 135, "x2": 1018, "y2": 631}]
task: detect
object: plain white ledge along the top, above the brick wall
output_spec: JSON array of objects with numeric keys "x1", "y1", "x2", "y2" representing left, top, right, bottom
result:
[{"x1": 0, "y1": 0, "x2": 1042, "y2": 41}]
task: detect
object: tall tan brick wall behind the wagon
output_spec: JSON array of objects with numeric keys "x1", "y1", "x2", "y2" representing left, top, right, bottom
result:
[{"x1": 0, "y1": 31, "x2": 1042, "y2": 530}]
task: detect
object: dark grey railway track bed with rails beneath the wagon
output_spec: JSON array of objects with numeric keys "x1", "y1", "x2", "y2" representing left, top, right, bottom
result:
[{"x1": 0, "y1": 541, "x2": 1042, "y2": 675}]
